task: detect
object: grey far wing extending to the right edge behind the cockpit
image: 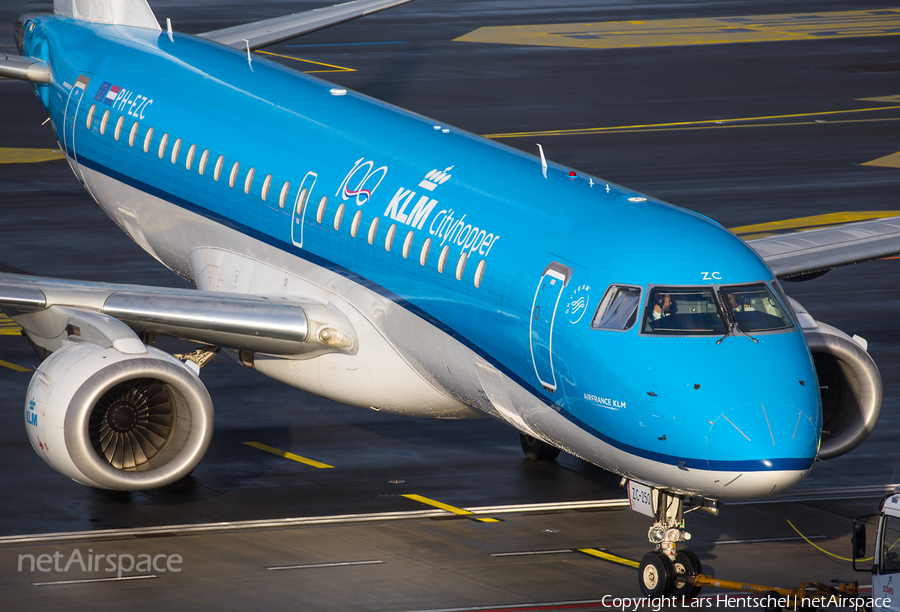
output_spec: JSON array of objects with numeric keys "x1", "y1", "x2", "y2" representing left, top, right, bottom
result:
[{"x1": 747, "y1": 217, "x2": 900, "y2": 278}]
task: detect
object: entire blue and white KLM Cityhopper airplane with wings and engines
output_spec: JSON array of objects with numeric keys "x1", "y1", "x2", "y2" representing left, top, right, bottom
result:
[{"x1": 0, "y1": 0, "x2": 888, "y2": 595}]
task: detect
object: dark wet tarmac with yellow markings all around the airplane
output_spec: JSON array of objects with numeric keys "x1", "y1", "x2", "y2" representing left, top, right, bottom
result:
[{"x1": 0, "y1": 0, "x2": 900, "y2": 612}]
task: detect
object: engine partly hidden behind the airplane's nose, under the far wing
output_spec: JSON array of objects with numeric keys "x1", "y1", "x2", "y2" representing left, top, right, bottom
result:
[{"x1": 791, "y1": 299, "x2": 883, "y2": 459}]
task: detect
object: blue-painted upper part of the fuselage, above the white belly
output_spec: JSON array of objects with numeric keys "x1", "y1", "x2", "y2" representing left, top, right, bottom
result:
[{"x1": 23, "y1": 16, "x2": 821, "y2": 494}]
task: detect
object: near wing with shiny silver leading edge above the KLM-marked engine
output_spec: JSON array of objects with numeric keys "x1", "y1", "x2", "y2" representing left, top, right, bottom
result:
[{"x1": 0, "y1": 273, "x2": 357, "y2": 356}]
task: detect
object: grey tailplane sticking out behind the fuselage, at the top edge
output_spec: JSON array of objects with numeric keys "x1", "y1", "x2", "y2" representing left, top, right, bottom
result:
[{"x1": 198, "y1": 0, "x2": 412, "y2": 51}]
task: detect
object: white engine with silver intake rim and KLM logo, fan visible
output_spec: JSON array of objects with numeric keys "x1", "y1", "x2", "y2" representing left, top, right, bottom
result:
[{"x1": 25, "y1": 343, "x2": 213, "y2": 491}]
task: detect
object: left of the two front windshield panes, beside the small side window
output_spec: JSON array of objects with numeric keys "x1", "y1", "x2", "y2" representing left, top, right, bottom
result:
[{"x1": 642, "y1": 287, "x2": 727, "y2": 336}]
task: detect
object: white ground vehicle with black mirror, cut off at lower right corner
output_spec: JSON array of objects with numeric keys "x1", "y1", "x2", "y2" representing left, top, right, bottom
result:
[{"x1": 853, "y1": 487, "x2": 900, "y2": 612}]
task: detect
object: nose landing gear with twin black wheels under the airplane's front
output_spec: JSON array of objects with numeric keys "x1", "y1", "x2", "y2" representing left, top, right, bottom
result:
[{"x1": 638, "y1": 489, "x2": 703, "y2": 597}]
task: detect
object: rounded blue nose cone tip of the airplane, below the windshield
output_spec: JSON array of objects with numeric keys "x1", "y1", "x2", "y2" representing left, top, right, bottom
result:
[{"x1": 706, "y1": 403, "x2": 820, "y2": 476}]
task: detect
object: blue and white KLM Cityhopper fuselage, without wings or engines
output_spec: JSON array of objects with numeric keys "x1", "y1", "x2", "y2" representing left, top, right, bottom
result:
[{"x1": 24, "y1": 15, "x2": 821, "y2": 498}]
